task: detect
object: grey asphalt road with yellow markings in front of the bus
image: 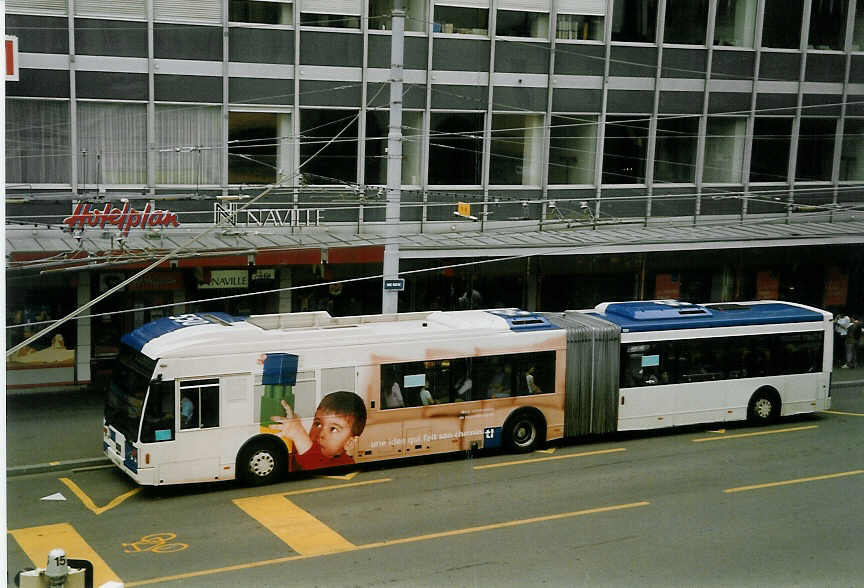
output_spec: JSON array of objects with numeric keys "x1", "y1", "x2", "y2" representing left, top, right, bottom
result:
[{"x1": 7, "y1": 386, "x2": 864, "y2": 587}]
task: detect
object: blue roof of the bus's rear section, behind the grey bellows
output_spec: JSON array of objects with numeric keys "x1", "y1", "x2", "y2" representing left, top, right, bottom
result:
[{"x1": 589, "y1": 301, "x2": 824, "y2": 333}]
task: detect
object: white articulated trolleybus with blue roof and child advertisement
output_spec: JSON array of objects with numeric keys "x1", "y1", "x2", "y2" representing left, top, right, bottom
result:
[{"x1": 103, "y1": 301, "x2": 833, "y2": 485}]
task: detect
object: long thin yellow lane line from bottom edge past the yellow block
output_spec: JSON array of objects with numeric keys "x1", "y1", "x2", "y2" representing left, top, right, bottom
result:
[{"x1": 125, "y1": 501, "x2": 651, "y2": 588}]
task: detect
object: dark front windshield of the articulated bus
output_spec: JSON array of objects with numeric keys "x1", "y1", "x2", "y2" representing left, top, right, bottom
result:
[{"x1": 105, "y1": 347, "x2": 156, "y2": 440}]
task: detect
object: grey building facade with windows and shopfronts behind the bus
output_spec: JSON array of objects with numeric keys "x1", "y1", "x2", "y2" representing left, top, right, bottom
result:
[{"x1": 5, "y1": 0, "x2": 864, "y2": 392}]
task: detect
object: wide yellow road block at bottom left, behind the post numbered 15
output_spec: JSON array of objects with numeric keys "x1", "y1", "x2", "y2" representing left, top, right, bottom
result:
[{"x1": 9, "y1": 523, "x2": 122, "y2": 586}]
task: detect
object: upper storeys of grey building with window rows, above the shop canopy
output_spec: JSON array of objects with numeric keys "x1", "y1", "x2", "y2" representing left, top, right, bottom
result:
[{"x1": 5, "y1": 0, "x2": 864, "y2": 222}]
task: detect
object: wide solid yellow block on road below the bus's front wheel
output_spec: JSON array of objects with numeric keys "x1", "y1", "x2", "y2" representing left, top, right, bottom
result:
[{"x1": 234, "y1": 494, "x2": 355, "y2": 555}]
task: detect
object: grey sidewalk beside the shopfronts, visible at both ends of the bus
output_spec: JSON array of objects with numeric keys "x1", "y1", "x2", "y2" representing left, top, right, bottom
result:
[{"x1": 6, "y1": 367, "x2": 864, "y2": 476}]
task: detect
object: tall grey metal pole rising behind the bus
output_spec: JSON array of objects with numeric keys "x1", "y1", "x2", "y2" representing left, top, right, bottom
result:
[{"x1": 381, "y1": 0, "x2": 405, "y2": 314}]
